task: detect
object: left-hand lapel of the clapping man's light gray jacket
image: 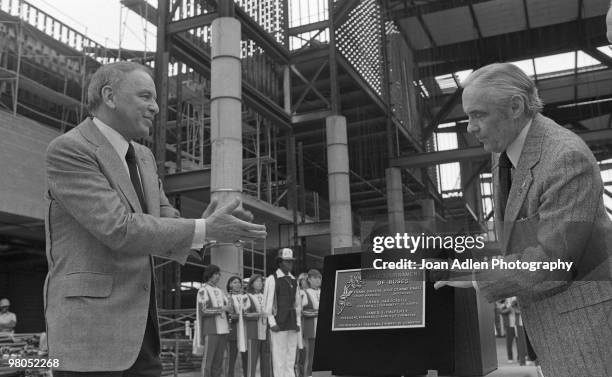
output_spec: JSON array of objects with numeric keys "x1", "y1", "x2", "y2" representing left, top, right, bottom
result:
[{"x1": 80, "y1": 119, "x2": 142, "y2": 213}]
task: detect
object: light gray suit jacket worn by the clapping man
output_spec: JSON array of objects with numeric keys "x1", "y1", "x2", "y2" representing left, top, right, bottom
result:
[{"x1": 44, "y1": 119, "x2": 195, "y2": 371}]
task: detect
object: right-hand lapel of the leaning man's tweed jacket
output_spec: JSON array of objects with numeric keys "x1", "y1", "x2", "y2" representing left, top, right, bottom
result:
[{"x1": 497, "y1": 114, "x2": 544, "y2": 250}]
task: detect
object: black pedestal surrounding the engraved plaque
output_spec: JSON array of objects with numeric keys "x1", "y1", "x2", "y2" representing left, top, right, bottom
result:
[{"x1": 313, "y1": 253, "x2": 497, "y2": 377}]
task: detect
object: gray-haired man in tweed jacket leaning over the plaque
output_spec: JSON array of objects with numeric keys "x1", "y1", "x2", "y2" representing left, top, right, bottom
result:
[{"x1": 436, "y1": 63, "x2": 612, "y2": 377}]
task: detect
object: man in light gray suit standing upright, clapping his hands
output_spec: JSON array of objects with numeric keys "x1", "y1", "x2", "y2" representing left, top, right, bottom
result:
[{"x1": 44, "y1": 62, "x2": 266, "y2": 377}]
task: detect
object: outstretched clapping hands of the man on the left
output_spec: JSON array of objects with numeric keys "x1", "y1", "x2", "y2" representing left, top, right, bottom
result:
[{"x1": 202, "y1": 198, "x2": 267, "y2": 243}]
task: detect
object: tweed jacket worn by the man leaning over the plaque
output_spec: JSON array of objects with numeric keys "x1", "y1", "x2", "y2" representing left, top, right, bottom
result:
[{"x1": 477, "y1": 115, "x2": 612, "y2": 377}]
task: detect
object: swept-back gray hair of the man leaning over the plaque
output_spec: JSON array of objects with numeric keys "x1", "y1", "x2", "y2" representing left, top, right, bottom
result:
[{"x1": 461, "y1": 63, "x2": 544, "y2": 116}]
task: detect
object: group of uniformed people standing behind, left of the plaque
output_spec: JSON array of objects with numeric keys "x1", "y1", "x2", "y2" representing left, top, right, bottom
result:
[{"x1": 194, "y1": 248, "x2": 321, "y2": 377}]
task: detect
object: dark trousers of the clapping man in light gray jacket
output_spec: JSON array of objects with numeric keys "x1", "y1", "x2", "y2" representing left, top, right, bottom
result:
[{"x1": 53, "y1": 313, "x2": 162, "y2": 377}]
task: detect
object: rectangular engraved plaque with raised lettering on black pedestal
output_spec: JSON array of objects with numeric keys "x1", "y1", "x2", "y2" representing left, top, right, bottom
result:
[{"x1": 332, "y1": 269, "x2": 425, "y2": 331}]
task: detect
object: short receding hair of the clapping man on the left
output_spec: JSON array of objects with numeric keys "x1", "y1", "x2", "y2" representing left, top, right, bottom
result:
[{"x1": 87, "y1": 61, "x2": 153, "y2": 115}]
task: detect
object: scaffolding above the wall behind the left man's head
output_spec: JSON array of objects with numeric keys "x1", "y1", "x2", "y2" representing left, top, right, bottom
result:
[{"x1": 0, "y1": 0, "x2": 152, "y2": 132}]
